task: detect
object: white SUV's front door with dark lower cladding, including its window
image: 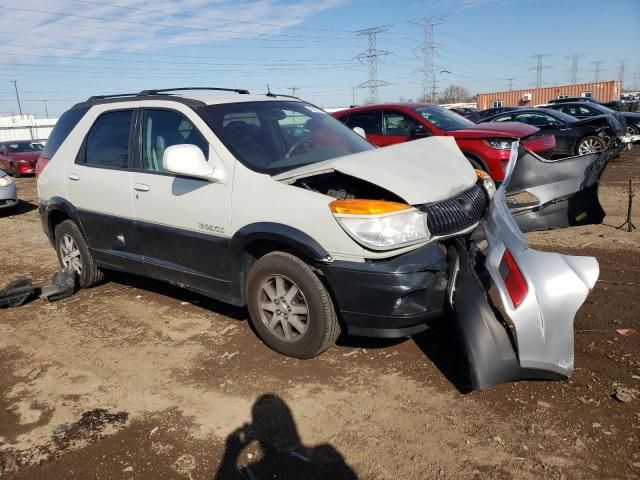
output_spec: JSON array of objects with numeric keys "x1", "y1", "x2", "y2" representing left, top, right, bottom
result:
[{"x1": 132, "y1": 104, "x2": 231, "y2": 296}]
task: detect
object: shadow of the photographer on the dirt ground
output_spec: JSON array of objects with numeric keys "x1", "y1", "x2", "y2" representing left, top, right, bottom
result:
[{"x1": 214, "y1": 394, "x2": 358, "y2": 480}]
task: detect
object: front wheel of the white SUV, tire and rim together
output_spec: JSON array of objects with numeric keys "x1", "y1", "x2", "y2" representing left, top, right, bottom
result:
[{"x1": 246, "y1": 252, "x2": 340, "y2": 359}]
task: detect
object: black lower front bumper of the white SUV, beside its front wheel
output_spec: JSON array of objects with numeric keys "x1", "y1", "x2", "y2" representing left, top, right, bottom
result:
[{"x1": 319, "y1": 242, "x2": 447, "y2": 338}]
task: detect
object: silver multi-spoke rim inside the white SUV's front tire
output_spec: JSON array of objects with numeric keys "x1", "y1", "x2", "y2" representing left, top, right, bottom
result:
[{"x1": 258, "y1": 275, "x2": 309, "y2": 342}]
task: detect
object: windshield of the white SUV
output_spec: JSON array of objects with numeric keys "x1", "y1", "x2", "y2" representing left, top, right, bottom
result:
[{"x1": 198, "y1": 101, "x2": 375, "y2": 175}]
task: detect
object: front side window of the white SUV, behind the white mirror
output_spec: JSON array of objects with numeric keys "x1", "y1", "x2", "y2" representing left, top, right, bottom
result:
[{"x1": 142, "y1": 109, "x2": 209, "y2": 172}]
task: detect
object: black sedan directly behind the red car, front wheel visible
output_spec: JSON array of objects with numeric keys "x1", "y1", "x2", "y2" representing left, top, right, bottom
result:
[{"x1": 480, "y1": 108, "x2": 618, "y2": 157}]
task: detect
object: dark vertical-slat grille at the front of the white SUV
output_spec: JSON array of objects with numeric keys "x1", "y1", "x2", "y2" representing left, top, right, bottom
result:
[{"x1": 417, "y1": 184, "x2": 489, "y2": 237}]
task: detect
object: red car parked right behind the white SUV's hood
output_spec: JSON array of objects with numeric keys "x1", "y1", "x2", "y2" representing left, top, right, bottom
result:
[{"x1": 333, "y1": 103, "x2": 556, "y2": 182}]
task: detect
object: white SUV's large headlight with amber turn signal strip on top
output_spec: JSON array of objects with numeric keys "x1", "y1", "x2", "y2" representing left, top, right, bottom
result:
[{"x1": 329, "y1": 200, "x2": 431, "y2": 250}]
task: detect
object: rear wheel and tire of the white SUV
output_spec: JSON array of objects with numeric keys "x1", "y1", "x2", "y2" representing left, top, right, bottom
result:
[{"x1": 54, "y1": 220, "x2": 104, "y2": 288}]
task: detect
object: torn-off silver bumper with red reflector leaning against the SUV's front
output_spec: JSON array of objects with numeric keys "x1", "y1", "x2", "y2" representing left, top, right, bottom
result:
[{"x1": 449, "y1": 142, "x2": 599, "y2": 389}]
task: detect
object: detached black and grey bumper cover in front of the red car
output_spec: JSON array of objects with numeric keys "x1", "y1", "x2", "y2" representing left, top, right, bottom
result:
[{"x1": 505, "y1": 145, "x2": 616, "y2": 232}]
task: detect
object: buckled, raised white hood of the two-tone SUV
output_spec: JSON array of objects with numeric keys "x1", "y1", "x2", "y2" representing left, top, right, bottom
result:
[{"x1": 273, "y1": 137, "x2": 477, "y2": 205}]
